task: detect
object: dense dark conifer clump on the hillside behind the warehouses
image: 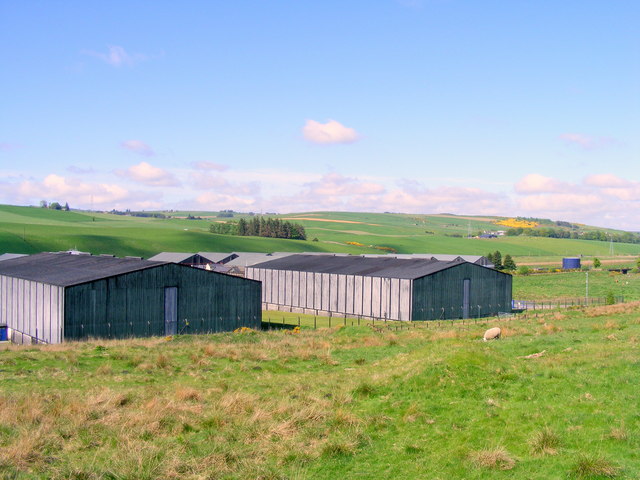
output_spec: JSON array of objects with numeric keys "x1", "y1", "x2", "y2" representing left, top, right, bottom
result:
[{"x1": 209, "y1": 217, "x2": 307, "y2": 240}]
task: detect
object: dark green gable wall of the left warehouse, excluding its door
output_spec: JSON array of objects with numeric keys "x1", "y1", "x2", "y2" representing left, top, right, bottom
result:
[{"x1": 65, "y1": 264, "x2": 262, "y2": 340}]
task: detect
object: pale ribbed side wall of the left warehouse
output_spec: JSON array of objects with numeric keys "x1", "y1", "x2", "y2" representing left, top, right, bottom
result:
[{"x1": 0, "y1": 275, "x2": 64, "y2": 343}]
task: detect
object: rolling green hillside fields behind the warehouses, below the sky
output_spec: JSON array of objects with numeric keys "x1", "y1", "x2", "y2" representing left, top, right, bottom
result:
[{"x1": 0, "y1": 205, "x2": 640, "y2": 263}]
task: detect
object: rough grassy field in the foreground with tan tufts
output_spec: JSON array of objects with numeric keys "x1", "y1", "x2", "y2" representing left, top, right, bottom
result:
[{"x1": 0, "y1": 303, "x2": 640, "y2": 479}]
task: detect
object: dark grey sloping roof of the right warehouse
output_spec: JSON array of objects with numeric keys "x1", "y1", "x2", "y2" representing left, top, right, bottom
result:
[{"x1": 254, "y1": 255, "x2": 466, "y2": 279}]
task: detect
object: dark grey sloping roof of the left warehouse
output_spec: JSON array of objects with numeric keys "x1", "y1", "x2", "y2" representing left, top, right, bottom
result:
[{"x1": 0, "y1": 252, "x2": 166, "y2": 287}]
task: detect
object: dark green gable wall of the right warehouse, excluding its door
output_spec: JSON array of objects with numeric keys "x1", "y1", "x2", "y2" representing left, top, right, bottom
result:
[{"x1": 413, "y1": 263, "x2": 512, "y2": 320}]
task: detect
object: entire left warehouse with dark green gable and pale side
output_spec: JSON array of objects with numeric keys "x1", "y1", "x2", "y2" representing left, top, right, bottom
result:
[{"x1": 0, "y1": 253, "x2": 262, "y2": 343}]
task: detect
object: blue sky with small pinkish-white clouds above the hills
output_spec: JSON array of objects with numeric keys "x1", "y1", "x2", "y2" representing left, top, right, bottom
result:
[{"x1": 0, "y1": 0, "x2": 640, "y2": 230}]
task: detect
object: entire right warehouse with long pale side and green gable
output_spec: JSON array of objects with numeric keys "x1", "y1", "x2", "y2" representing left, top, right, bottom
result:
[{"x1": 247, "y1": 255, "x2": 511, "y2": 320}]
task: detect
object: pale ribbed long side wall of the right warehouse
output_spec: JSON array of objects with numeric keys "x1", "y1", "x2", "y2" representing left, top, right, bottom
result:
[{"x1": 247, "y1": 267, "x2": 411, "y2": 320}]
